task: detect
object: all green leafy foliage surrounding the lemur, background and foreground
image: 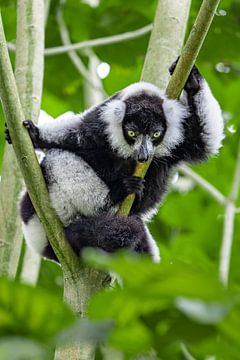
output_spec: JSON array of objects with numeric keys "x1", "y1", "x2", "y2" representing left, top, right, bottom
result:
[{"x1": 0, "y1": 0, "x2": 240, "y2": 360}]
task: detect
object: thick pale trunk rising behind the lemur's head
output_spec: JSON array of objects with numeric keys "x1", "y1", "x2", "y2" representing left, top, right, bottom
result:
[{"x1": 142, "y1": 0, "x2": 191, "y2": 89}]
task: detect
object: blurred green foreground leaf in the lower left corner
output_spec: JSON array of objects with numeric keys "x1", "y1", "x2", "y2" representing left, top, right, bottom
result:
[{"x1": 0, "y1": 278, "x2": 75, "y2": 360}]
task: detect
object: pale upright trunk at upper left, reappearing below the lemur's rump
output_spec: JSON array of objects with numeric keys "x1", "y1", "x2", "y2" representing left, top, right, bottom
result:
[{"x1": 15, "y1": 0, "x2": 44, "y2": 284}]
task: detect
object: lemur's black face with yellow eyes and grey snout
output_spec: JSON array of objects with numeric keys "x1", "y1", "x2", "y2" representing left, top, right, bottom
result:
[{"x1": 122, "y1": 94, "x2": 166, "y2": 162}]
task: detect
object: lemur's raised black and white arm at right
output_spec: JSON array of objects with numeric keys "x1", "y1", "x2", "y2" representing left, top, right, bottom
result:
[{"x1": 170, "y1": 66, "x2": 224, "y2": 163}]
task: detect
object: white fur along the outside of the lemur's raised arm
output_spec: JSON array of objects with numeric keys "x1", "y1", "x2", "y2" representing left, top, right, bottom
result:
[{"x1": 194, "y1": 80, "x2": 224, "y2": 154}]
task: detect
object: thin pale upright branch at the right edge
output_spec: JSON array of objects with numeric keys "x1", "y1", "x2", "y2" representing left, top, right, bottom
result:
[{"x1": 219, "y1": 144, "x2": 240, "y2": 286}]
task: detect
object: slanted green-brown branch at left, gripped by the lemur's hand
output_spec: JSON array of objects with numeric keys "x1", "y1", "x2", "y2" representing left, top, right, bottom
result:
[{"x1": 0, "y1": 11, "x2": 79, "y2": 274}]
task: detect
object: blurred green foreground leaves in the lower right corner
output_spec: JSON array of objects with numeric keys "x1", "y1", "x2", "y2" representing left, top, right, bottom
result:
[{"x1": 79, "y1": 250, "x2": 240, "y2": 359}]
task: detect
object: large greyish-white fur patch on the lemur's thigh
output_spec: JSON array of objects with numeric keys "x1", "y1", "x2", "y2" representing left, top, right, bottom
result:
[{"x1": 44, "y1": 149, "x2": 116, "y2": 226}]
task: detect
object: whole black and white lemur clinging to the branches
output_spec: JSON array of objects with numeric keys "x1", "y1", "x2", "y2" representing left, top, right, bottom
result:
[{"x1": 7, "y1": 67, "x2": 224, "y2": 262}]
